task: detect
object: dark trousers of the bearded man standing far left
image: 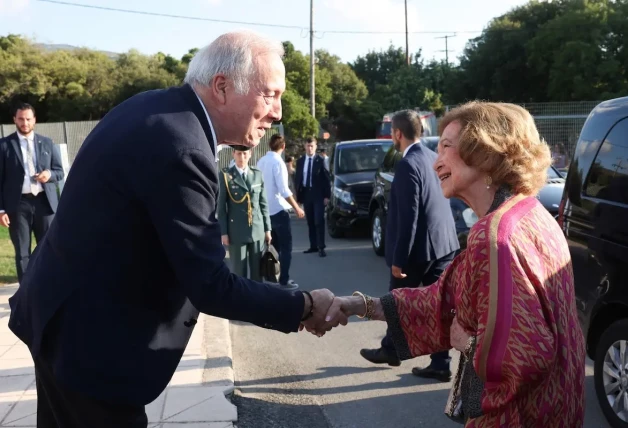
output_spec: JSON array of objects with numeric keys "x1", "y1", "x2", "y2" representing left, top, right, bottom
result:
[{"x1": 7, "y1": 192, "x2": 54, "y2": 282}]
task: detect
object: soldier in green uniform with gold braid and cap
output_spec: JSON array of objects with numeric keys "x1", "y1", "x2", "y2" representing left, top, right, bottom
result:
[{"x1": 218, "y1": 146, "x2": 271, "y2": 281}]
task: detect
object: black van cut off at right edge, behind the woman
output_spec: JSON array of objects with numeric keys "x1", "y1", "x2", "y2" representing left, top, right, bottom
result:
[{"x1": 558, "y1": 97, "x2": 628, "y2": 427}]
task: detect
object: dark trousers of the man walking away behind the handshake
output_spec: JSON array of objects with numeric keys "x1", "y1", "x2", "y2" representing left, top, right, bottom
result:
[{"x1": 382, "y1": 252, "x2": 456, "y2": 370}]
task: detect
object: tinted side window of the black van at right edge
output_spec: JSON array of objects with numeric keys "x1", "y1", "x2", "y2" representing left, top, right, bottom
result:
[{"x1": 585, "y1": 118, "x2": 628, "y2": 204}]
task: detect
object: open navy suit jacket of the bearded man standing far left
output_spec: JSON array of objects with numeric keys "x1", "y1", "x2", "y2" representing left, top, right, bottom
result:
[{"x1": 0, "y1": 133, "x2": 64, "y2": 217}]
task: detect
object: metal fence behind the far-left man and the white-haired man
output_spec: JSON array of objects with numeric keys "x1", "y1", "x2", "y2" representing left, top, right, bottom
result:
[{"x1": 0, "y1": 120, "x2": 284, "y2": 168}]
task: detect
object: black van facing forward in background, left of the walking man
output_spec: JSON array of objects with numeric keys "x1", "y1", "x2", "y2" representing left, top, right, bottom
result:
[{"x1": 326, "y1": 140, "x2": 392, "y2": 238}]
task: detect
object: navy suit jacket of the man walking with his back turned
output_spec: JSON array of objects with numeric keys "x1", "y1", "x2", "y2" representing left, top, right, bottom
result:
[{"x1": 384, "y1": 143, "x2": 460, "y2": 269}]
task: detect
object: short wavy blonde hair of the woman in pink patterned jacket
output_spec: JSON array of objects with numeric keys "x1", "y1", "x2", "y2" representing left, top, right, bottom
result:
[{"x1": 438, "y1": 101, "x2": 552, "y2": 195}]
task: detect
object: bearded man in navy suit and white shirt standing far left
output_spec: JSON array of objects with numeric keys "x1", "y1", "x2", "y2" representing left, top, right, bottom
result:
[{"x1": 0, "y1": 103, "x2": 64, "y2": 283}]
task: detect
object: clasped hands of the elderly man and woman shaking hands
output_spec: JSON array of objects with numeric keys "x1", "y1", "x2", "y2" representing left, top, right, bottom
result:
[{"x1": 299, "y1": 289, "x2": 385, "y2": 337}]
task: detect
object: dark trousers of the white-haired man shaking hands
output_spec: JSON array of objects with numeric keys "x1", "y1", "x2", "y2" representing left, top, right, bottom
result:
[{"x1": 33, "y1": 340, "x2": 148, "y2": 428}]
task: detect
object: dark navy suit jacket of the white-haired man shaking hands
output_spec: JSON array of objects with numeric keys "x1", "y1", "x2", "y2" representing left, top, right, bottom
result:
[{"x1": 9, "y1": 85, "x2": 304, "y2": 405}]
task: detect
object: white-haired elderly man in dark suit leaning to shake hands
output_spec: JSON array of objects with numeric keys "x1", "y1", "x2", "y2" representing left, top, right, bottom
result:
[{"x1": 9, "y1": 31, "x2": 346, "y2": 428}]
